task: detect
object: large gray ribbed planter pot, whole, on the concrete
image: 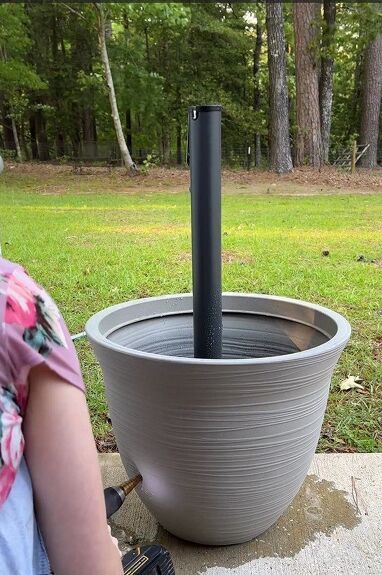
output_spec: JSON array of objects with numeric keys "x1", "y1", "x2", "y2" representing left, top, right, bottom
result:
[{"x1": 86, "y1": 294, "x2": 350, "y2": 545}]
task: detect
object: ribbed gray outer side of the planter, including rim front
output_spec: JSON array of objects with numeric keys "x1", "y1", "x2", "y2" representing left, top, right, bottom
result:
[{"x1": 87, "y1": 296, "x2": 350, "y2": 545}]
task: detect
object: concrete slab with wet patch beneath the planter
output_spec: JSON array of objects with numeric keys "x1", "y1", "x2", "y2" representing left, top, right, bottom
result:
[{"x1": 99, "y1": 454, "x2": 382, "y2": 575}]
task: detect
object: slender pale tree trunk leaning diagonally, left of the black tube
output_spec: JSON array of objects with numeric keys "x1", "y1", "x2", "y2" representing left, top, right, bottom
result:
[{"x1": 94, "y1": 4, "x2": 137, "y2": 172}]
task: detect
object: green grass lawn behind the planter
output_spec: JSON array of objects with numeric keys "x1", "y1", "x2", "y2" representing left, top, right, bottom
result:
[{"x1": 0, "y1": 169, "x2": 382, "y2": 451}]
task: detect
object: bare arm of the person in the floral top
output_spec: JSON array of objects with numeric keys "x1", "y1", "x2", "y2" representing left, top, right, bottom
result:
[{"x1": 24, "y1": 365, "x2": 122, "y2": 575}]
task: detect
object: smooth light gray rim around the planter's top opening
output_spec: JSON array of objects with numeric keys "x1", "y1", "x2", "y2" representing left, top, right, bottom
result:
[{"x1": 85, "y1": 292, "x2": 351, "y2": 366}]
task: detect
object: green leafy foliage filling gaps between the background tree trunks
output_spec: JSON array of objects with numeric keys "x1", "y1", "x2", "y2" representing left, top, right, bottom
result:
[{"x1": 0, "y1": 2, "x2": 382, "y2": 161}]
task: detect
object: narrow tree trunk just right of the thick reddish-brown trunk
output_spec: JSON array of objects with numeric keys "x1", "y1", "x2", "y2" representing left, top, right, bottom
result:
[{"x1": 320, "y1": 0, "x2": 336, "y2": 163}]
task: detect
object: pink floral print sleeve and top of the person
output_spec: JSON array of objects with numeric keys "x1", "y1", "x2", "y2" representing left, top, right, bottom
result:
[{"x1": 0, "y1": 258, "x2": 84, "y2": 507}]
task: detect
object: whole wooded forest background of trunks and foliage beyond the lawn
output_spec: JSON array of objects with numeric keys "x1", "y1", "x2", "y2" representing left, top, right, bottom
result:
[{"x1": 0, "y1": 0, "x2": 382, "y2": 173}]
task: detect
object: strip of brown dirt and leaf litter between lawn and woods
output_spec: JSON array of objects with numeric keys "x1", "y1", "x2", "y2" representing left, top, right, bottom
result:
[{"x1": 6, "y1": 163, "x2": 382, "y2": 195}]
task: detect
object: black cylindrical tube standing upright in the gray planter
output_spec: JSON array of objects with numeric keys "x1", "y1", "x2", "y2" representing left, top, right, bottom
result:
[{"x1": 188, "y1": 106, "x2": 223, "y2": 359}]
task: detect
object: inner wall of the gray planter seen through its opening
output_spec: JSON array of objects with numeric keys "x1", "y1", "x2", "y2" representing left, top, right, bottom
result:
[{"x1": 104, "y1": 311, "x2": 333, "y2": 359}]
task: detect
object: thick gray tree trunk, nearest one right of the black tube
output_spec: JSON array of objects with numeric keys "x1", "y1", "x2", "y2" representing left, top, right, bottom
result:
[{"x1": 266, "y1": 0, "x2": 293, "y2": 174}]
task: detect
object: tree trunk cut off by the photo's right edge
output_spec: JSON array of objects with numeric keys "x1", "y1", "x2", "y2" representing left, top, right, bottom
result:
[{"x1": 359, "y1": 35, "x2": 382, "y2": 168}]
